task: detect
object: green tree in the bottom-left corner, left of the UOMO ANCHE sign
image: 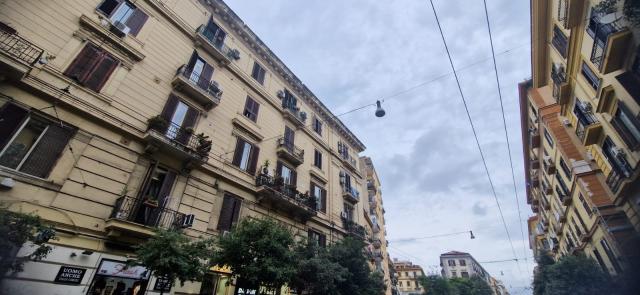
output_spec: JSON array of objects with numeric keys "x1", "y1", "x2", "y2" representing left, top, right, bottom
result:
[{"x1": 0, "y1": 209, "x2": 56, "y2": 277}]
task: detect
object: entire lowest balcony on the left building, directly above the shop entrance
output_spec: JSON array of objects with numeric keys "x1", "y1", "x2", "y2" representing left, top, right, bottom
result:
[{"x1": 105, "y1": 197, "x2": 185, "y2": 237}]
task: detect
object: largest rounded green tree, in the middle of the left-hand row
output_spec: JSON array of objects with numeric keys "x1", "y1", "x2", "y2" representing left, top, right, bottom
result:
[{"x1": 211, "y1": 219, "x2": 297, "y2": 294}]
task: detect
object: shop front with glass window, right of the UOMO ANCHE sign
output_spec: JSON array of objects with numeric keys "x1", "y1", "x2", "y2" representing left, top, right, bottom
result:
[{"x1": 87, "y1": 259, "x2": 150, "y2": 295}]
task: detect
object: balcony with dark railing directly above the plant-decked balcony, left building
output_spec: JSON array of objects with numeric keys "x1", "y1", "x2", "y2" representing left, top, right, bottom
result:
[{"x1": 171, "y1": 65, "x2": 222, "y2": 110}]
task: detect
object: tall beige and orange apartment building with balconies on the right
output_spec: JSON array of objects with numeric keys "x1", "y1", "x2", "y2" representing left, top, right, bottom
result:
[{"x1": 519, "y1": 0, "x2": 640, "y2": 276}]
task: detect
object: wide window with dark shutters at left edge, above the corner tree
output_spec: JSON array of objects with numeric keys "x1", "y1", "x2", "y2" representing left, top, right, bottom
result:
[{"x1": 0, "y1": 103, "x2": 75, "y2": 178}]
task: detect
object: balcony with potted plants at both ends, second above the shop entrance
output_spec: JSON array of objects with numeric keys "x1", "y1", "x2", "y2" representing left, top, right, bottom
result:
[{"x1": 144, "y1": 116, "x2": 212, "y2": 168}]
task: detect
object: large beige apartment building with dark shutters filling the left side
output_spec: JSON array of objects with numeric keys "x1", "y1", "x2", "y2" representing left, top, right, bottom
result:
[{"x1": 0, "y1": 0, "x2": 376, "y2": 295}]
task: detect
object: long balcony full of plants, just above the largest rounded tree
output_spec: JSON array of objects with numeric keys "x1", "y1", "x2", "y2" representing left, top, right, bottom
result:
[{"x1": 256, "y1": 174, "x2": 318, "y2": 222}]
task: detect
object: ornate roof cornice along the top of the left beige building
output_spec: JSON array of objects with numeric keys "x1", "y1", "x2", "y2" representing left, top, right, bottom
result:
[{"x1": 199, "y1": 0, "x2": 366, "y2": 152}]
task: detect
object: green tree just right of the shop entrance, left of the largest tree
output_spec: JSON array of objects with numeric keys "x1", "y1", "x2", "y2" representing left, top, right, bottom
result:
[{"x1": 129, "y1": 229, "x2": 213, "y2": 294}]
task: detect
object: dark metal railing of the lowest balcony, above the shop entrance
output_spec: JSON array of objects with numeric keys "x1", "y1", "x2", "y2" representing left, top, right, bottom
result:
[{"x1": 109, "y1": 197, "x2": 185, "y2": 229}]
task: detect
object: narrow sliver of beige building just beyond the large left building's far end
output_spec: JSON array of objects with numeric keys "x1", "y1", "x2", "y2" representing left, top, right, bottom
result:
[{"x1": 360, "y1": 157, "x2": 397, "y2": 295}]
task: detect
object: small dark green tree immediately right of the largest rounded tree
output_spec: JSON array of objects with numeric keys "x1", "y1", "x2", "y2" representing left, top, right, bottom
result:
[{"x1": 289, "y1": 241, "x2": 348, "y2": 295}]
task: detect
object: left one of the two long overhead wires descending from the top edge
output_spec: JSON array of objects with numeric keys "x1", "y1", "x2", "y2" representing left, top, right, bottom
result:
[{"x1": 429, "y1": 0, "x2": 522, "y2": 271}]
